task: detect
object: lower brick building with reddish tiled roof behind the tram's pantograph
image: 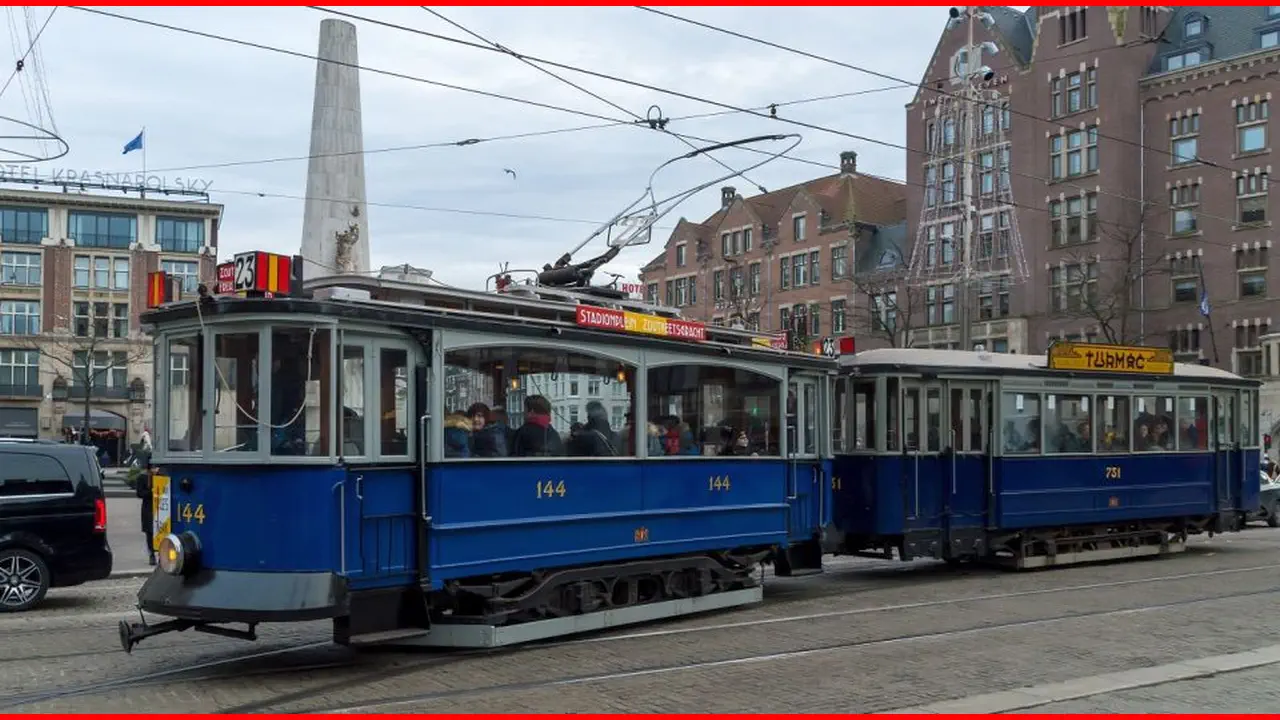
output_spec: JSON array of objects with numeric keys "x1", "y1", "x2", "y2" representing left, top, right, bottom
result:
[{"x1": 640, "y1": 152, "x2": 906, "y2": 347}]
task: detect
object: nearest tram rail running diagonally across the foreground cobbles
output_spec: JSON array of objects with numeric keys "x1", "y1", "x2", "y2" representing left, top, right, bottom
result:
[{"x1": 312, "y1": 585, "x2": 1280, "y2": 714}]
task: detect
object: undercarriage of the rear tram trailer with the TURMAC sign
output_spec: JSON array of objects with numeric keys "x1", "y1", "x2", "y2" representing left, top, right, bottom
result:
[{"x1": 836, "y1": 514, "x2": 1240, "y2": 570}]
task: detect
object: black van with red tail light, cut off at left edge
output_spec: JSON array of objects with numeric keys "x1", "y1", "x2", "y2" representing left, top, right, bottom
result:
[{"x1": 0, "y1": 438, "x2": 111, "y2": 612}]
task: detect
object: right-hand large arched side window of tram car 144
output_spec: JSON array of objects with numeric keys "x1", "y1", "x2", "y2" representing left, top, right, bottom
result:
[{"x1": 644, "y1": 357, "x2": 778, "y2": 460}]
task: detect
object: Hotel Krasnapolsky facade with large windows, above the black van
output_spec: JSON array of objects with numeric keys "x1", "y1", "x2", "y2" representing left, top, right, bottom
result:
[{"x1": 0, "y1": 186, "x2": 223, "y2": 461}]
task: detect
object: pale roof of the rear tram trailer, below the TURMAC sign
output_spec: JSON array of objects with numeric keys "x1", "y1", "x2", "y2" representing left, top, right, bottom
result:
[{"x1": 838, "y1": 347, "x2": 1261, "y2": 384}]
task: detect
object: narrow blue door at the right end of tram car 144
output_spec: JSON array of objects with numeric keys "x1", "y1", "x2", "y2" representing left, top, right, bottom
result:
[{"x1": 787, "y1": 375, "x2": 829, "y2": 541}]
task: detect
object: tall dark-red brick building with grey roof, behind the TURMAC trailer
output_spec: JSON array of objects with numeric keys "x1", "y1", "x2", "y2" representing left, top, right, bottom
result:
[{"x1": 906, "y1": 6, "x2": 1280, "y2": 374}]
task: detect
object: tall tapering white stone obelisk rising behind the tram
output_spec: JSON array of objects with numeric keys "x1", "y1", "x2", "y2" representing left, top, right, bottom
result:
[{"x1": 302, "y1": 19, "x2": 370, "y2": 279}]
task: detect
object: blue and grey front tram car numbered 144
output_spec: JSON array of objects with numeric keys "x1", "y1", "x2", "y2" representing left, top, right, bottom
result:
[{"x1": 119, "y1": 266, "x2": 836, "y2": 651}]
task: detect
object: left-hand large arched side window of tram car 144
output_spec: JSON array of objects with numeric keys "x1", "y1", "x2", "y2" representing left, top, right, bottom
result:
[{"x1": 433, "y1": 341, "x2": 637, "y2": 462}]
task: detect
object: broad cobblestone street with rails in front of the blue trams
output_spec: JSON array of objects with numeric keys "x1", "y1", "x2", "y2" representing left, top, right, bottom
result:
[{"x1": 0, "y1": 528, "x2": 1280, "y2": 712}]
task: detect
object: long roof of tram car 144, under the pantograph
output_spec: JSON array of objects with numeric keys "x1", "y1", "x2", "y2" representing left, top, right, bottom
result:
[{"x1": 142, "y1": 270, "x2": 836, "y2": 370}]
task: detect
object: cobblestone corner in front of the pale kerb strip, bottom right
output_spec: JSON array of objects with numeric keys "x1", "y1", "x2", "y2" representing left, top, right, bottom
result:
[{"x1": 1018, "y1": 665, "x2": 1280, "y2": 715}]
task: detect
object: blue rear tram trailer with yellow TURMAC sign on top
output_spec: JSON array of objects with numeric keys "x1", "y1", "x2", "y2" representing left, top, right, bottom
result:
[{"x1": 826, "y1": 343, "x2": 1260, "y2": 569}]
